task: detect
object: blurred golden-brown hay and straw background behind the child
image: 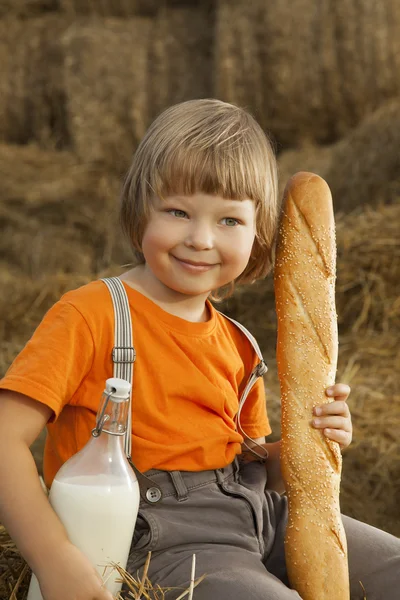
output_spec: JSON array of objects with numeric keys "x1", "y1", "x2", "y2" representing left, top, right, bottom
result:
[{"x1": 0, "y1": 0, "x2": 400, "y2": 600}]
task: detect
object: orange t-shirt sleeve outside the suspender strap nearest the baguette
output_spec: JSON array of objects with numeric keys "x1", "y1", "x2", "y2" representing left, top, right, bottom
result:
[{"x1": 240, "y1": 340, "x2": 272, "y2": 438}]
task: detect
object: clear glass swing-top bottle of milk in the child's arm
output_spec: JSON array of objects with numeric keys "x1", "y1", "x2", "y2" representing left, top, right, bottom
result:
[{"x1": 28, "y1": 377, "x2": 140, "y2": 600}]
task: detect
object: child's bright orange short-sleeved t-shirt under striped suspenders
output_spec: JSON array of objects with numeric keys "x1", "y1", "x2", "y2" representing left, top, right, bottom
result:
[{"x1": 0, "y1": 281, "x2": 271, "y2": 486}]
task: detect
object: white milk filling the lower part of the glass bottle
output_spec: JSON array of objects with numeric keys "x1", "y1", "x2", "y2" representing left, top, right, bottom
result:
[{"x1": 28, "y1": 474, "x2": 140, "y2": 600}]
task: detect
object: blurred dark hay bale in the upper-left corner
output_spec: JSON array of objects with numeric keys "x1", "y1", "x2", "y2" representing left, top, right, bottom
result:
[{"x1": 0, "y1": 16, "x2": 69, "y2": 148}]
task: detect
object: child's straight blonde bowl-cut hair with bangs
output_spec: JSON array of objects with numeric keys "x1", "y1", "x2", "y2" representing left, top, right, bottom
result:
[{"x1": 120, "y1": 99, "x2": 279, "y2": 299}]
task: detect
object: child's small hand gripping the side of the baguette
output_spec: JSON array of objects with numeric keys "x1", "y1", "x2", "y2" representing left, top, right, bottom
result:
[{"x1": 312, "y1": 383, "x2": 353, "y2": 450}]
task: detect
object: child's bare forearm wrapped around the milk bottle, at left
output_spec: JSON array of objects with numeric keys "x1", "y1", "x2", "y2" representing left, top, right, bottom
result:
[{"x1": 0, "y1": 430, "x2": 68, "y2": 573}]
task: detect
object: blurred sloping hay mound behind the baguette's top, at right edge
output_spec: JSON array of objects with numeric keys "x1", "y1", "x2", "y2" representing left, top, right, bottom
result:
[{"x1": 278, "y1": 100, "x2": 400, "y2": 212}]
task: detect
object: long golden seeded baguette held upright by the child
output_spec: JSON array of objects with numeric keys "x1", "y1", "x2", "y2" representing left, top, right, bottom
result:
[{"x1": 274, "y1": 172, "x2": 350, "y2": 600}]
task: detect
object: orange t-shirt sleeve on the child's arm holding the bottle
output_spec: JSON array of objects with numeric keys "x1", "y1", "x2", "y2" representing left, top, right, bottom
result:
[{"x1": 0, "y1": 299, "x2": 94, "y2": 420}]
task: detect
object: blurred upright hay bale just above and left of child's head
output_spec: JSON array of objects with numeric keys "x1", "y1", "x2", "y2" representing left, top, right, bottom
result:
[{"x1": 63, "y1": 17, "x2": 152, "y2": 173}]
